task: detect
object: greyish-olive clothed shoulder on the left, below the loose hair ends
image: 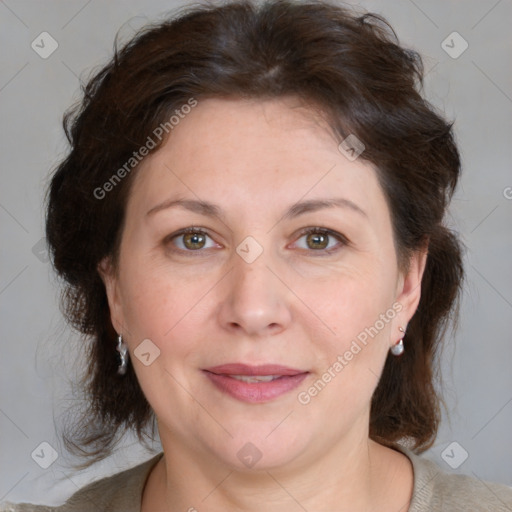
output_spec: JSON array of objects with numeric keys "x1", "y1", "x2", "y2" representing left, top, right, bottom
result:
[{"x1": 0, "y1": 453, "x2": 163, "y2": 512}]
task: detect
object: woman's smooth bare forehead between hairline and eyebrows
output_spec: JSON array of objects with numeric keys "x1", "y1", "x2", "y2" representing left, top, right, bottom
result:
[{"x1": 126, "y1": 97, "x2": 383, "y2": 222}]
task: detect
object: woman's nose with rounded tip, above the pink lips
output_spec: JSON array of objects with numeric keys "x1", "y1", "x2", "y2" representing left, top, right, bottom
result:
[{"x1": 219, "y1": 251, "x2": 293, "y2": 337}]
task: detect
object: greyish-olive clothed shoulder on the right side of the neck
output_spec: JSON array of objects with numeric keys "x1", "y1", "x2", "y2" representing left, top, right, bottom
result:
[{"x1": 399, "y1": 447, "x2": 512, "y2": 512}]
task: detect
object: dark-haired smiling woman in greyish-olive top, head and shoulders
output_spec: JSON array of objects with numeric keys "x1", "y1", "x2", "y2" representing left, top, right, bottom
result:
[{"x1": 5, "y1": 1, "x2": 512, "y2": 512}]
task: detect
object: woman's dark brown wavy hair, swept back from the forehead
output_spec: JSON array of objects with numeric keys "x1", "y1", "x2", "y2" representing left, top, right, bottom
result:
[{"x1": 46, "y1": 0, "x2": 463, "y2": 467}]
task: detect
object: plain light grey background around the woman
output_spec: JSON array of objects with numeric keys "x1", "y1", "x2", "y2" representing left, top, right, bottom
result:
[{"x1": 0, "y1": 0, "x2": 512, "y2": 504}]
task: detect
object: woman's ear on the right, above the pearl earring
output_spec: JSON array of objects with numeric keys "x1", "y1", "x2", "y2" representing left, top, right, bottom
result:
[{"x1": 396, "y1": 242, "x2": 428, "y2": 329}]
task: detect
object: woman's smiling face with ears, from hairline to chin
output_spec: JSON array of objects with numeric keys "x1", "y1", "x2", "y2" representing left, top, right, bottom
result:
[{"x1": 101, "y1": 98, "x2": 424, "y2": 469}]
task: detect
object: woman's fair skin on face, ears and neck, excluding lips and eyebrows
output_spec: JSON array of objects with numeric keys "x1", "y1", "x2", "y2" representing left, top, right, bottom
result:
[{"x1": 99, "y1": 97, "x2": 426, "y2": 512}]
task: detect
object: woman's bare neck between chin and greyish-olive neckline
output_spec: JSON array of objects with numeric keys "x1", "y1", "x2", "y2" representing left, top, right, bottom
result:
[{"x1": 142, "y1": 422, "x2": 412, "y2": 512}]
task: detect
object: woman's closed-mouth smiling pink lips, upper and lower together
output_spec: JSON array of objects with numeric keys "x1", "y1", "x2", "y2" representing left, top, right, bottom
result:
[{"x1": 203, "y1": 363, "x2": 309, "y2": 404}]
